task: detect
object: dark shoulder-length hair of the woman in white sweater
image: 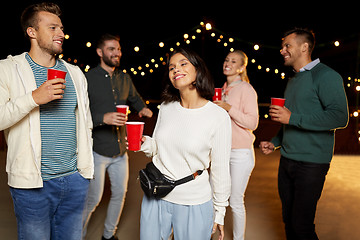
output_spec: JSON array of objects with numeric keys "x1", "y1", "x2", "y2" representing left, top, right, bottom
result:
[{"x1": 162, "y1": 48, "x2": 215, "y2": 103}]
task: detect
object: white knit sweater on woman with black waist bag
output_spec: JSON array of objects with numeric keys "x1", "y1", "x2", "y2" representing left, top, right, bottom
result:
[{"x1": 141, "y1": 102, "x2": 231, "y2": 225}]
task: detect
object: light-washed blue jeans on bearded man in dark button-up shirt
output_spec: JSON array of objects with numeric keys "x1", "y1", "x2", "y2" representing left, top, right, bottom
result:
[{"x1": 83, "y1": 152, "x2": 129, "y2": 238}]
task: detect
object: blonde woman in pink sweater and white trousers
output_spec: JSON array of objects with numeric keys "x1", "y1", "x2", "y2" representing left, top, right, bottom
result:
[{"x1": 215, "y1": 50, "x2": 259, "y2": 240}]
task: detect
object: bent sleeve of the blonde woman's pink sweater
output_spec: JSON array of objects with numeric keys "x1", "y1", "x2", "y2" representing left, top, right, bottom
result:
[{"x1": 229, "y1": 85, "x2": 259, "y2": 131}]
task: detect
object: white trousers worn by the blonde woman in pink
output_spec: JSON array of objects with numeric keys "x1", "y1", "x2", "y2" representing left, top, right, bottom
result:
[{"x1": 230, "y1": 149, "x2": 255, "y2": 240}]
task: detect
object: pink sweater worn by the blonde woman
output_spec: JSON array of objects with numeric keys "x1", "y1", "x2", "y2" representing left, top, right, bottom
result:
[{"x1": 223, "y1": 81, "x2": 259, "y2": 149}]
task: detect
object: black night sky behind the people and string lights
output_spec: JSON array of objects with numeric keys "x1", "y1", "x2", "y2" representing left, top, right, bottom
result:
[{"x1": 0, "y1": 1, "x2": 360, "y2": 109}]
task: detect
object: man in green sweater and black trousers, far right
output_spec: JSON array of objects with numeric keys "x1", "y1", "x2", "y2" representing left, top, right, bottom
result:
[{"x1": 260, "y1": 28, "x2": 349, "y2": 240}]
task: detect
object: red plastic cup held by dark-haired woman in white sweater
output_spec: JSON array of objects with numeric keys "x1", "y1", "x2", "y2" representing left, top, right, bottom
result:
[{"x1": 126, "y1": 122, "x2": 145, "y2": 151}]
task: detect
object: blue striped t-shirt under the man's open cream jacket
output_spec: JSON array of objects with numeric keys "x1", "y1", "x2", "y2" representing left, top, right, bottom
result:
[{"x1": 26, "y1": 54, "x2": 77, "y2": 181}]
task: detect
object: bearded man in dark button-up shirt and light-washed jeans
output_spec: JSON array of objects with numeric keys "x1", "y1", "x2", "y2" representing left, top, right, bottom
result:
[{"x1": 83, "y1": 34, "x2": 152, "y2": 239}]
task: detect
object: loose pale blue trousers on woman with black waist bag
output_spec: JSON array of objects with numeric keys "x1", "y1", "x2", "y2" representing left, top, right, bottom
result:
[{"x1": 140, "y1": 195, "x2": 214, "y2": 240}]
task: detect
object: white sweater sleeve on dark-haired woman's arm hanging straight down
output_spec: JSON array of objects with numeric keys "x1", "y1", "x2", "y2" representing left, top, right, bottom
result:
[{"x1": 210, "y1": 113, "x2": 231, "y2": 225}]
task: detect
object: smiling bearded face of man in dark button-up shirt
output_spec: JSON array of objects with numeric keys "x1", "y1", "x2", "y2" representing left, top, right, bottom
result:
[{"x1": 97, "y1": 40, "x2": 122, "y2": 67}]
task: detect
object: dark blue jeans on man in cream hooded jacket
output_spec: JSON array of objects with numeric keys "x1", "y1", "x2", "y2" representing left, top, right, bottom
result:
[{"x1": 10, "y1": 172, "x2": 89, "y2": 240}]
